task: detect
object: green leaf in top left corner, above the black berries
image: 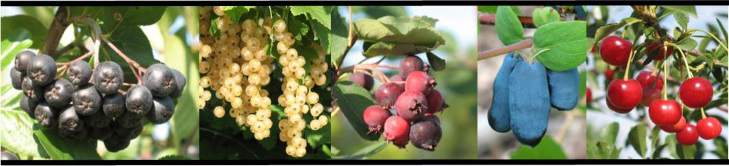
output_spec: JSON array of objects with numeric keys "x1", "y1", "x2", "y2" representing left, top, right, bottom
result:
[{"x1": 0, "y1": 15, "x2": 48, "y2": 48}]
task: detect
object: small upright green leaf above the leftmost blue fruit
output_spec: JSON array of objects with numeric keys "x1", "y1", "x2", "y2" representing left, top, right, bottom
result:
[{"x1": 494, "y1": 6, "x2": 524, "y2": 45}]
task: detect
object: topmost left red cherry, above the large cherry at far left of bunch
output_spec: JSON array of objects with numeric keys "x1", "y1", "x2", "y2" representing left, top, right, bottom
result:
[{"x1": 600, "y1": 36, "x2": 633, "y2": 66}]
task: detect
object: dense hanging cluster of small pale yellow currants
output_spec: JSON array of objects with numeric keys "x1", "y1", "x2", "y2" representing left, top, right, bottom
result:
[{"x1": 197, "y1": 7, "x2": 329, "y2": 157}]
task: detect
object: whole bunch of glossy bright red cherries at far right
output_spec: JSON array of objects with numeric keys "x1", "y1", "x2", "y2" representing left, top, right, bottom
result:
[{"x1": 600, "y1": 36, "x2": 722, "y2": 145}]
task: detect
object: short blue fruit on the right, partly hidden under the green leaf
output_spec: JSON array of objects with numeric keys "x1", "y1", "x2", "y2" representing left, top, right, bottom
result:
[{"x1": 547, "y1": 68, "x2": 580, "y2": 111}]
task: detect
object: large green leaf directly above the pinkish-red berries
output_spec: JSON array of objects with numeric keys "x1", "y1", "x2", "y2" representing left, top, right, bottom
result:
[{"x1": 354, "y1": 16, "x2": 445, "y2": 57}]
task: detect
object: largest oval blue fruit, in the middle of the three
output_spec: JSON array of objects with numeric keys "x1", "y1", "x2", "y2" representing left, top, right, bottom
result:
[{"x1": 509, "y1": 61, "x2": 550, "y2": 146}]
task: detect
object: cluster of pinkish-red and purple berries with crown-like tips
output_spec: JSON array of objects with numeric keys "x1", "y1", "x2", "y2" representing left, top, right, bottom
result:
[{"x1": 350, "y1": 55, "x2": 447, "y2": 151}]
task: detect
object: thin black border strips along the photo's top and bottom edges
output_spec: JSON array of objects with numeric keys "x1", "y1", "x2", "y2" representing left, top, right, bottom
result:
[{"x1": 2, "y1": 0, "x2": 729, "y2": 165}]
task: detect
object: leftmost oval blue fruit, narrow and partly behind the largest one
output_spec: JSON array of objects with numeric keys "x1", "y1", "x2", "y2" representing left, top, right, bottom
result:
[{"x1": 487, "y1": 54, "x2": 521, "y2": 132}]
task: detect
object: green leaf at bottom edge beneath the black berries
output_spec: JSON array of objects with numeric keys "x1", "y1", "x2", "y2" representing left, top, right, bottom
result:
[{"x1": 33, "y1": 126, "x2": 101, "y2": 160}]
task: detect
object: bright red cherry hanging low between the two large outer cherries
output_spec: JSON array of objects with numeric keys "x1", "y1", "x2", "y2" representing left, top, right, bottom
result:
[{"x1": 648, "y1": 99, "x2": 683, "y2": 126}]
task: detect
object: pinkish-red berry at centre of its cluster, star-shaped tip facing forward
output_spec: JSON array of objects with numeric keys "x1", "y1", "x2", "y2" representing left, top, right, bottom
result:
[{"x1": 395, "y1": 91, "x2": 428, "y2": 121}]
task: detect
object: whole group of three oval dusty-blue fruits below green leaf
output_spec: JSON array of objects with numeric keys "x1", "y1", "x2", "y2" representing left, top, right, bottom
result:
[{"x1": 488, "y1": 54, "x2": 580, "y2": 146}]
